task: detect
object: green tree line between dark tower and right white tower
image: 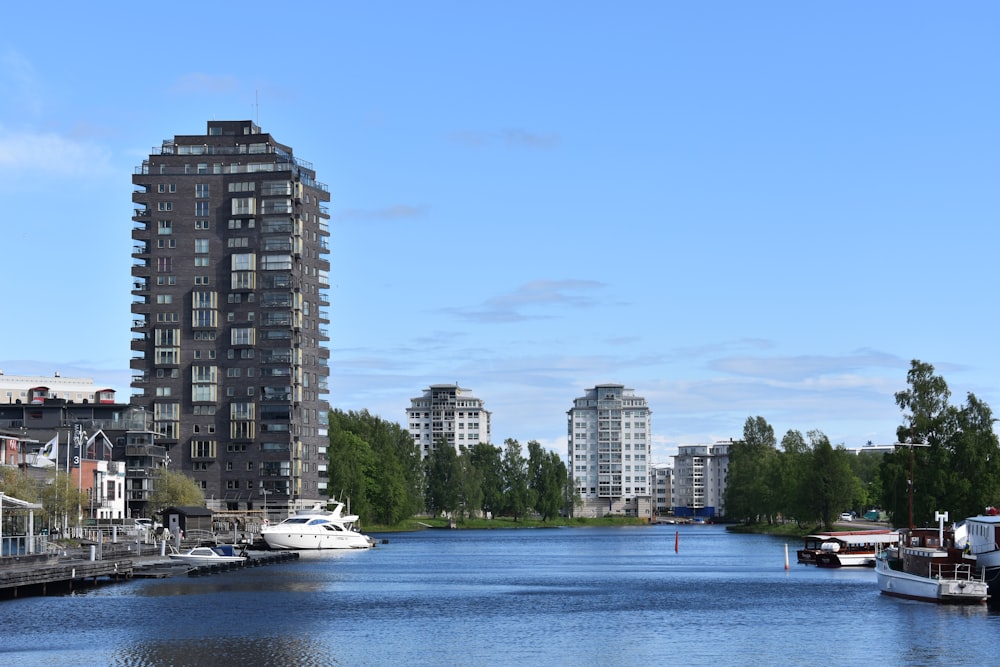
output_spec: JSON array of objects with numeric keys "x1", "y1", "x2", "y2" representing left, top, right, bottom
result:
[{"x1": 329, "y1": 410, "x2": 569, "y2": 525}]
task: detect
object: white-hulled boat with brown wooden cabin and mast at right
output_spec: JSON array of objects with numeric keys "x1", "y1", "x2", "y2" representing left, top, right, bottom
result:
[{"x1": 875, "y1": 513, "x2": 989, "y2": 604}]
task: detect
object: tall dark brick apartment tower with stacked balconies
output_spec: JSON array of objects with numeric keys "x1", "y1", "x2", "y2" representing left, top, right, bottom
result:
[{"x1": 131, "y1": 121, "x2": 330, "y2": 510}]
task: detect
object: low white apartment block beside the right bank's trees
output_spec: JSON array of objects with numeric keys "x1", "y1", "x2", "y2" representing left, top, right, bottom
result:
[{"x1": 671, "y1": 442, "x2": 732, "y2": 517}]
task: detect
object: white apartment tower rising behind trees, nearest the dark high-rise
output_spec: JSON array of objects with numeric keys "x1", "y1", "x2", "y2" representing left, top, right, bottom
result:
[{"x1": 406, "y1": 384, "x2": 490, "y2": 458}]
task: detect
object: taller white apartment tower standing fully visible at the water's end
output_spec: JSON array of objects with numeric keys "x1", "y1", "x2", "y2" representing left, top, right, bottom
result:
[{"x1": 566, "y1": 384, "x2": 652, "y2": 517}]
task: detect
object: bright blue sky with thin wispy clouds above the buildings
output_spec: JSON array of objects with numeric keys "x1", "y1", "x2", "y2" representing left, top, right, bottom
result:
[{"x1": 0, "y1": 1, "x2": 1000, "y2": 462}]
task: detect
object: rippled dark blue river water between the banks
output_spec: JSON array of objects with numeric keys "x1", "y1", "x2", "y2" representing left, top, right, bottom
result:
[{"x1": 0, "y1": 526, "x2": 1000, "y2": 667}]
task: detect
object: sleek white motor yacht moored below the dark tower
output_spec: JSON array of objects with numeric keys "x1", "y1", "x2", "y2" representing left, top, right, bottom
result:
[{"x1": 260, "y1": 502, "x2": 375, "y2": 549}]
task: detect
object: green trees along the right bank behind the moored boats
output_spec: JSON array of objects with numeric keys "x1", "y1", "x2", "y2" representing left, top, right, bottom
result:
[{"x1": 725, "y1": 360, "x2": 1000, "y2": 528}]
